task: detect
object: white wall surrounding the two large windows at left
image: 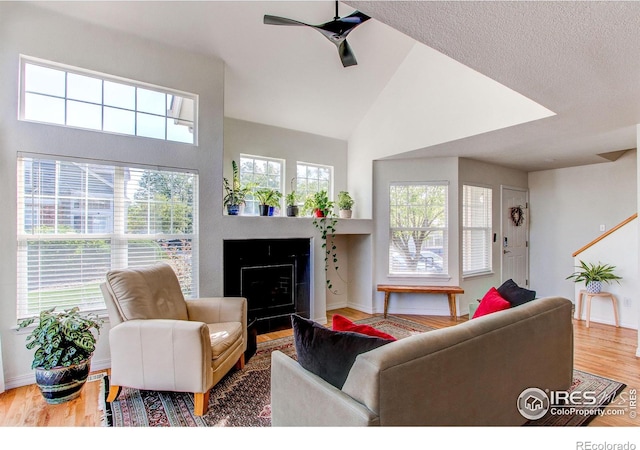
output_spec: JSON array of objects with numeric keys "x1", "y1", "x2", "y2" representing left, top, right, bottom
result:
[{"x1": 0, "y1": 2, "x2": 224, "y2": 388}]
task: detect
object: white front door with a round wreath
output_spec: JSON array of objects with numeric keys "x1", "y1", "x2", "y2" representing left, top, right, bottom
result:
[{"x1": 501, "y1": 186, "x2": 529, "y2": 288}]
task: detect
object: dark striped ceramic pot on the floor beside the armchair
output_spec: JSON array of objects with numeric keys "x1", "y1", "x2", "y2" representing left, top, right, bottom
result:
[{"x1": 36, "y1": 359, "x2": 91, "y2": 405}]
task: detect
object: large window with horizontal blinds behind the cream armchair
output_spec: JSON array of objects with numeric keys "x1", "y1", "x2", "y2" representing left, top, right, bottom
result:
[{"x1": 17, "y1": 156, "x2": 198, "y2": 319}]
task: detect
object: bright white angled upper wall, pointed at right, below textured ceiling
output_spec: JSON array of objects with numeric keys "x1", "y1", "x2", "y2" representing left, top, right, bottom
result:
[{"x1": 348, "y1": 39, "x2": 554, "y2": 217}]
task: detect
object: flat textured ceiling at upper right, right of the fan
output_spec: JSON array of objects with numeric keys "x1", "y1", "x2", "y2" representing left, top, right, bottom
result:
[{"x1": 347, "y1": 1, "x2": 640, "y2": 170}]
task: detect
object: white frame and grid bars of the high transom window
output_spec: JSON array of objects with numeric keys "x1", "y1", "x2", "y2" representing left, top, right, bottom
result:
[{"x1": 18, "y1": 54, "x2": 199, "y2": 146}]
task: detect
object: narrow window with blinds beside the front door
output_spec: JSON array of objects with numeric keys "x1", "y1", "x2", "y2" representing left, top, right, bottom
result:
[{"x1": 462, "y1": 185, "x2": 492, "y2": 275}]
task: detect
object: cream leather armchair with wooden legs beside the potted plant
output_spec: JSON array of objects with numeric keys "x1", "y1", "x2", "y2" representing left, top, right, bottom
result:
[{"x1": 100, "y1": 263, "x2": 247, "y2": 416}]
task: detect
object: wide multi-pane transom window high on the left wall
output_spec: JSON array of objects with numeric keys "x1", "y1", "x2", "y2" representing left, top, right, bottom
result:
[{"x1": 20, "y1": 57, "x2": 197, "y2": 144}]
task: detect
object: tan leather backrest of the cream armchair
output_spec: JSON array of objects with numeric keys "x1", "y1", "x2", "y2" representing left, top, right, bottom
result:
[{"x1": 106, "y1": 263, "x2": 188, "y2": 320}]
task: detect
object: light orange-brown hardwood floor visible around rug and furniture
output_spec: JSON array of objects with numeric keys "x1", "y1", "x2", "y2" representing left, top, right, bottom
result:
[{"x1": 0, "y1": 309, "x2": 640, "y2": 427}]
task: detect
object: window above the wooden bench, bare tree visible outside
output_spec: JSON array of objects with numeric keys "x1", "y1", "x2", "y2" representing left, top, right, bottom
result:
[{"x1": 389, "y1": 183, "x2": 448, "y2": 276}]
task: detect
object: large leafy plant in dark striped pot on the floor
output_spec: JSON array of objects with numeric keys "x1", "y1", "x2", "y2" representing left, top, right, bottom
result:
[{"x1": 18, "y1": 307, "x2": 103, "y2": 404}]
